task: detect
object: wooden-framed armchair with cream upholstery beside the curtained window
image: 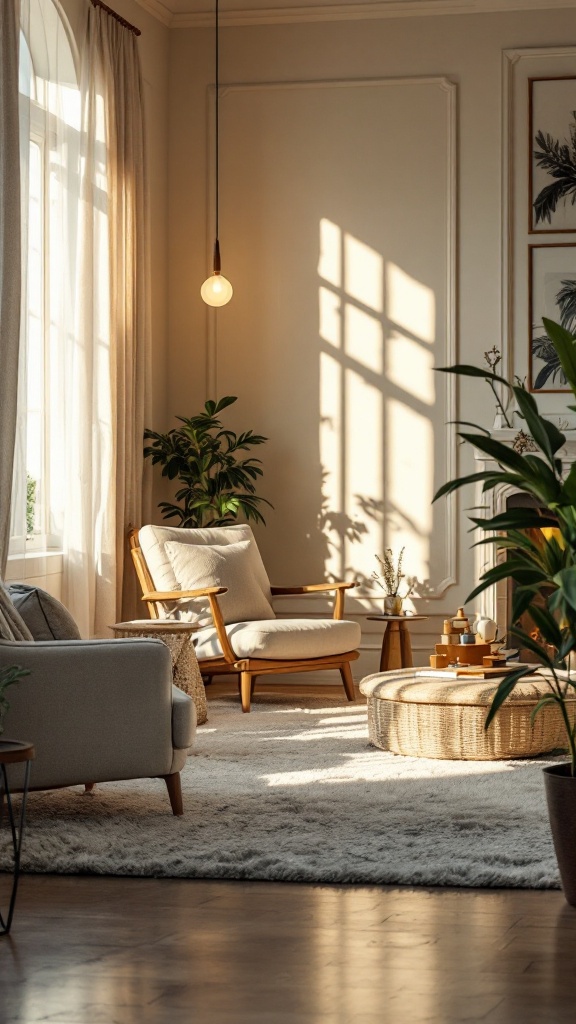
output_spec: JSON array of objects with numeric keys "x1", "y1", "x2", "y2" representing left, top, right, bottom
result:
[{"x1": 130, "y1": 525, "x2": 360, "y2": 712}]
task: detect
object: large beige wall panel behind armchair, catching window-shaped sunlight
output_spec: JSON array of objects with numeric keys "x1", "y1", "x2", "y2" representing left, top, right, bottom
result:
[{"x1": 201, "y1": 76, "x2": 458, "y2": 622}]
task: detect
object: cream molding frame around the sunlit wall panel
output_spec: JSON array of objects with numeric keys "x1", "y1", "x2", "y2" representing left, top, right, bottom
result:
[{"x1": 206, "y1": 76, "x2": 459, "y2": 601}]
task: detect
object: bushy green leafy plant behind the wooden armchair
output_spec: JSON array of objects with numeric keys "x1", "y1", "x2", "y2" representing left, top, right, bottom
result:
[{"x1": 145, "y1": 395, "x2": 272, "y2": 526}]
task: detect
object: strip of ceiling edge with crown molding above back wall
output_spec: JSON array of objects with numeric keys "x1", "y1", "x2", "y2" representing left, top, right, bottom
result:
[{"x1": 133, "y1": 0, "x2": 576, "y2": 29}]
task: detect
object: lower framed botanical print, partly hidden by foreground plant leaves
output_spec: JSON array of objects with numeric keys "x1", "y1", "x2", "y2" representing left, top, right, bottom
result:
[{"x1": 529, "y1": 243, "x2": 576, "y2": 392}]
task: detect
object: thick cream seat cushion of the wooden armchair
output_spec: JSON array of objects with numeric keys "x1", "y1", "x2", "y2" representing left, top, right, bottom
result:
[{"x1": 196, "y1": 618, "x2": 361, "y2": 662}]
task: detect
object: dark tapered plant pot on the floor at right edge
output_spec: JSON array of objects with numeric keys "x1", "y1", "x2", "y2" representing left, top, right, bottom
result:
[{"x1": 543, "y1": 763, "x2": 576, "y2": 906}]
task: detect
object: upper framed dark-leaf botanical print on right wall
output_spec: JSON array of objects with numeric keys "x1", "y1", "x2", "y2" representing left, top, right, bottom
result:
[{"x1": 528, "y1": 77, "x2": 576, "y2": 233}]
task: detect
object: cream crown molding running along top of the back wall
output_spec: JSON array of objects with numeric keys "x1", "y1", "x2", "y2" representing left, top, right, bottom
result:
[{"x1": 161, "y1": 0, "x2": 576, "y2": 29}]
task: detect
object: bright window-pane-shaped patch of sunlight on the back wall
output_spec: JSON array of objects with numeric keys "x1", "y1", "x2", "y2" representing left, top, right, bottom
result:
[{"x1": 318, "y1": 218, "x2": 436, "y2": 598}]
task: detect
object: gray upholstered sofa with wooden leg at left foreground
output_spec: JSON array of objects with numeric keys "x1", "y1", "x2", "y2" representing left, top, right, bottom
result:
[{"x1": 0, "y1": 590, "x2": 196, "y2": 814}]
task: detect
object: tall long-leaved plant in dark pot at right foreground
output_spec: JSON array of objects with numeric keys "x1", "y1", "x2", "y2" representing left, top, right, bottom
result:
[{"x1": 435, "y1": 319, "x2": 576, "y2": 905}]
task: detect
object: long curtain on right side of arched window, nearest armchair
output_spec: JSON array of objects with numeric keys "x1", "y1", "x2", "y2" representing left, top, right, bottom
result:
[{"x1": 65, "y1": 6, "x2": 150, "y2": 634}]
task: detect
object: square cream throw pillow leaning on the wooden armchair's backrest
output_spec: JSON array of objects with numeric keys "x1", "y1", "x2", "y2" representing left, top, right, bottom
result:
[{"x1": 166, "y1": 541, "x2": 275, "y2": 626}]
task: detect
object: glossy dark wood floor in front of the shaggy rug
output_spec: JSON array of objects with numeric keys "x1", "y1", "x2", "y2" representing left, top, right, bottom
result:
[{"x1": 0, "y1": 688, "x2": 576, "y2": 1024}]
